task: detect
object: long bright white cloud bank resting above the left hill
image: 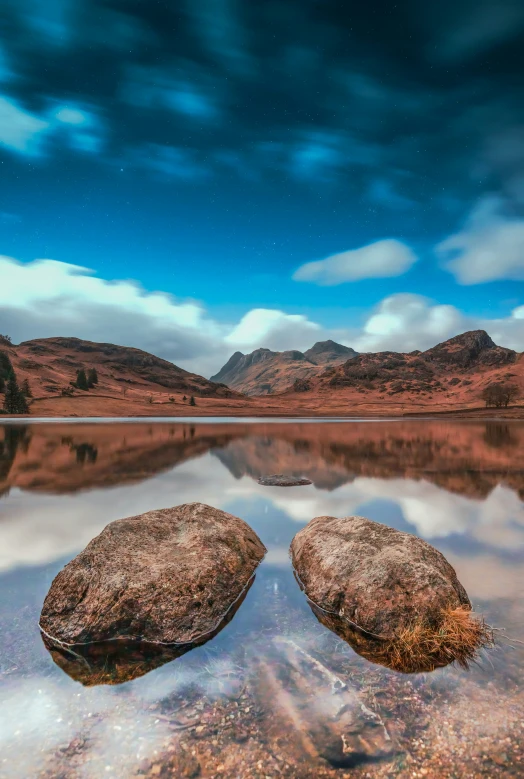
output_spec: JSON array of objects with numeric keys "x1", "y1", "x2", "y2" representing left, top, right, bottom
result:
[{"x1": 0, "y1": 256, "x2": 336, "y2": 376}]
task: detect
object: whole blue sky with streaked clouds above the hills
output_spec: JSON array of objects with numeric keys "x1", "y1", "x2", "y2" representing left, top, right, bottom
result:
[{"x1": 0, "y1": 0, "x2": 524, "y2": 376}]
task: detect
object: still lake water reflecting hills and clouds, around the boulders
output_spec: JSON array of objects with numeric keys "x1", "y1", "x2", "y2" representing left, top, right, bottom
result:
[{"x1": 0, "y1": 420, "x2": 524, "y2": 779}]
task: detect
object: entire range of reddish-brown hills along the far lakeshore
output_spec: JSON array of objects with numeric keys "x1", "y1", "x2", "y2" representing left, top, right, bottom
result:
[{"x1": 0, "y1": 330, "x2": 524, "y2": 417}]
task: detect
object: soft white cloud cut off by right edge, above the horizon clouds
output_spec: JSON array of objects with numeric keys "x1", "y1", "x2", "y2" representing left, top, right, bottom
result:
[{"x1": 437, "y1": 198, "x2": 524, "y2": 284}]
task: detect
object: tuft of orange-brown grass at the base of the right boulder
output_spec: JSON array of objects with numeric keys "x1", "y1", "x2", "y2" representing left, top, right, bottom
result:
[{"x1": 377, "y1": 606, "x2": 493, "y2": 673}]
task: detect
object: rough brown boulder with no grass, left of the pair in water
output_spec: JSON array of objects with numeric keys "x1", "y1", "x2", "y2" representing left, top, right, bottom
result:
[{"x1": 40, "y1": 503, "x2": 266, "y2": 649}]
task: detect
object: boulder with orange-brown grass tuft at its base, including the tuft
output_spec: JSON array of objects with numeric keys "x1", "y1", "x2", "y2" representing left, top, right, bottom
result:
[{"x1": 291, "y1": 517, "x2": 490, "y2": 672}]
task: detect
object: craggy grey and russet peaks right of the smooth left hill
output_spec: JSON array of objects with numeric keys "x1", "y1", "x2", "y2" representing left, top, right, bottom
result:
[{"x1": 211, "y1": 330, "x2": 519, "y2": 398}]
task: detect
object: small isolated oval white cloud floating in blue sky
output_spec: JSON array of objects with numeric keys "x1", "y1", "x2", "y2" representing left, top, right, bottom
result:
[{"x1": 293, "y1": 238, "x2": 417, "y2": 286}]
